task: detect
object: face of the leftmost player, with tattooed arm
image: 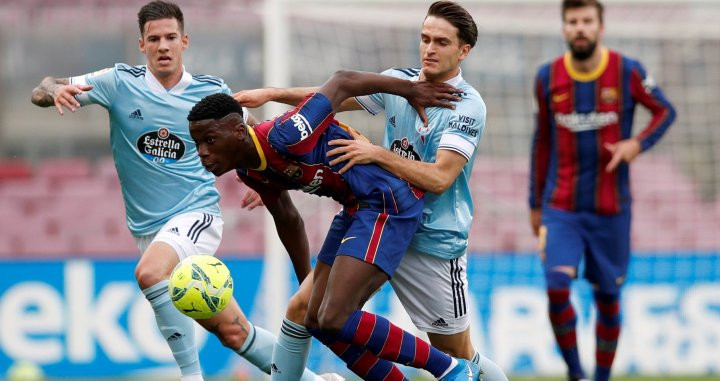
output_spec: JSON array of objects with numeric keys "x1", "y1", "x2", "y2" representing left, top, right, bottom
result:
[{"x1": 140, "y1": 18, "x2": 188, "y2": 78}]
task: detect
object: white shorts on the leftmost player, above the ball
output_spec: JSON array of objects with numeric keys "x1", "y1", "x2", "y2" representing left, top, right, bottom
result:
[{"x1": 134, "y1": 212, "x2": 223, "y2": 261}]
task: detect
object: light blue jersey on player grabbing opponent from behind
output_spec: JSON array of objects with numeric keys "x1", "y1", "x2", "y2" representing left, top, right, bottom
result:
[{"x1": 356, "y1": 69, "x2": 486, "y2": 259}]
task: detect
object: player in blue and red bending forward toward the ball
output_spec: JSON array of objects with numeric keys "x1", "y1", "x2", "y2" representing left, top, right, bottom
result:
[{"x1": 188, "y1": 71, "x2": 480, "y2": 381}]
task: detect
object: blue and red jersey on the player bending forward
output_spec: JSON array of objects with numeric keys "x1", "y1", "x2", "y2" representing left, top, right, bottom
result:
[{"x1": 237, "y1": 93, "x2": 422, "y2": 214}]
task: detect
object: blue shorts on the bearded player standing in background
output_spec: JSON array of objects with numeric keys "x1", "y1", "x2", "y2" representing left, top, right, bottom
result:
[{"x1": 540, "y1": 207, "x2": 631, "y2": 293}]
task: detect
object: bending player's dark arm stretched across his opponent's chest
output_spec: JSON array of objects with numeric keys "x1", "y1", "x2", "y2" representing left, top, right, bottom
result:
[{"x1": 317, "y1": 70, "x2": 461, "y2": 126}]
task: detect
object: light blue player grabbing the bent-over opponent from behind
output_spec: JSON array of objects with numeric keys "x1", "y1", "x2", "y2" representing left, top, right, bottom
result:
[{"x1": 235, "y1": 1, "x2": 507, "y2": 381}]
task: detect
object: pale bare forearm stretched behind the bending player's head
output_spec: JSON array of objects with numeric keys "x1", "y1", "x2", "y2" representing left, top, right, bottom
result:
[{"x1": 233, "y1": 87, "x2": 362, "y2": 112}]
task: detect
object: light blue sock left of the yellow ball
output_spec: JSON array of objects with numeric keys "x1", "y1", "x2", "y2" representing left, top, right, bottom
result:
[{"x1": 142, "y1": 280, "x2": 202, "y2": 376}]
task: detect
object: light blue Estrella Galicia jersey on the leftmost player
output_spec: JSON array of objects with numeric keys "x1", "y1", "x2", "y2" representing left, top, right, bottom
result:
[{"x1": 70, "y1": 64, "x2": 231, "y2": 236}]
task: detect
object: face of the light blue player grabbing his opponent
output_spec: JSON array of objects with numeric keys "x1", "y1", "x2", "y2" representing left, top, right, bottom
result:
[{"x1": 420, "y1": 16, "x2": 470, "y2": 81}]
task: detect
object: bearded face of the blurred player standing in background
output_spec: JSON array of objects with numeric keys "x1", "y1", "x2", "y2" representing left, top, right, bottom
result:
[{"x1": 563, "y1": 6, "x2": 604, "y2": 61}]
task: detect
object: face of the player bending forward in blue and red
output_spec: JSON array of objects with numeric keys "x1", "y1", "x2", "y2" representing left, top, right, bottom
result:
[{"x1": 190, "y1": 119, "x2": 241, "y2": 176}]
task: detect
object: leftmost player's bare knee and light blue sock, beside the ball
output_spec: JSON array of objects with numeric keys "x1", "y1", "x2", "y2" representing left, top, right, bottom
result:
[{"x1": 135, "y1": 242, "x2": 203, "y2": 381}]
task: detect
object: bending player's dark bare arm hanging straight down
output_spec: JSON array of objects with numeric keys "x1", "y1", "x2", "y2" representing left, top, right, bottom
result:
[{"x1": 260, "y1": 191, "x2": 310, "y2": 283}]
